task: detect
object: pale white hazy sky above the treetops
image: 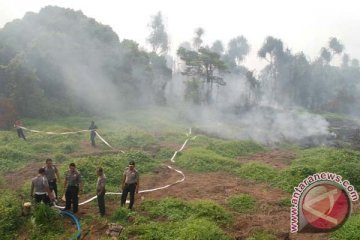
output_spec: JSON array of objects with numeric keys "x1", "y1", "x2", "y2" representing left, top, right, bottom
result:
[{"x1": 0, "y1": 0, "x2": 360, "y2": 68}]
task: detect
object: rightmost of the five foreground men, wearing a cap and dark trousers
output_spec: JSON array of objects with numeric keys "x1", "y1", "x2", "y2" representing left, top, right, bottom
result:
[{"x1": 121, "y1": 161, "x2": 140, "y2": 209}]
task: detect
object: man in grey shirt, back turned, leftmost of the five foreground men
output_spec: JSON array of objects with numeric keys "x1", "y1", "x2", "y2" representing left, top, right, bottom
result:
[{"x1": 30, "y1": 168, "x2": 53, "y2": 204}]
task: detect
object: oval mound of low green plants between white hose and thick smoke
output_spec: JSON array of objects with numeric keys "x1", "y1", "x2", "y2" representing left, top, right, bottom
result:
[{"x1": 207, "y1": 141, "x2": 265, "y2": 158}]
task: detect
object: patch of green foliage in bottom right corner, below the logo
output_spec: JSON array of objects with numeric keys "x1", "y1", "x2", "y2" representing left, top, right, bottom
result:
[{"x1": 330, "y1": 215, "x2": 360, "y2": 240}]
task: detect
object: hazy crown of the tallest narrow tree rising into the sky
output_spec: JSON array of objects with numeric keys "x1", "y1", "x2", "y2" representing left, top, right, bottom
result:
[{"x1": 147, "y1": 12, "x2": 169, "y2": 54}]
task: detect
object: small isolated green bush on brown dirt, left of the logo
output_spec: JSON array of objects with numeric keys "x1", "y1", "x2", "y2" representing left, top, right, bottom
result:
[{"x1": 226, "y1": 194, "x2": 256, "y2": 213}]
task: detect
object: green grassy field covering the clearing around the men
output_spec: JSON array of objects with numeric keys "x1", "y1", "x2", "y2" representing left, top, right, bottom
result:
[{"x1": 0, "y1": 109, "x2": 360, "y2": 240}]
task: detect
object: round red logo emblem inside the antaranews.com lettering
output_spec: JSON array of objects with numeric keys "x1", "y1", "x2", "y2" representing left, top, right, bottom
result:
[{"x1": 302, "y1": 183, "x2": 351, "y2": 231}]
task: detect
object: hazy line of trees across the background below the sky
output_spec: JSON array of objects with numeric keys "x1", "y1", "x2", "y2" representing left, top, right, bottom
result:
[{"x1": 0, "y1": 6, "x2": 360, "y2": 127}]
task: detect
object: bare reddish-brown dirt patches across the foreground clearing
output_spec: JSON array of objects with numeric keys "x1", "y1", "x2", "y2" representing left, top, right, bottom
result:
[{"x1": 5, "y1": 150, "x2": 329, "y2": 240}]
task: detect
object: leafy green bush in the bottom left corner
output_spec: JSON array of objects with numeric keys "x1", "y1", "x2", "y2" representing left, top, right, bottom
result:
[{"x1": 0, "y1": 191, "x2": 23, "y2": 240}]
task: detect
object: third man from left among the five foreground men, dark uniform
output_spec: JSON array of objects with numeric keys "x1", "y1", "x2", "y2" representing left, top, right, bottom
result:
[{"x1": 64, "y1": 163, "x2": 83, "y2": 213}]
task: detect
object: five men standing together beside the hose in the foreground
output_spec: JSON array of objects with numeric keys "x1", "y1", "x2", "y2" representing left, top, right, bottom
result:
[{"x1": 31, "y1": 158, "x2": 140, "y2": 216}]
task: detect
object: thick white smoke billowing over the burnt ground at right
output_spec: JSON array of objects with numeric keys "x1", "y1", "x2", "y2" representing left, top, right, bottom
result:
[{"x1": 167, "y1": 73, "x2": 332, "y2": 145}]
